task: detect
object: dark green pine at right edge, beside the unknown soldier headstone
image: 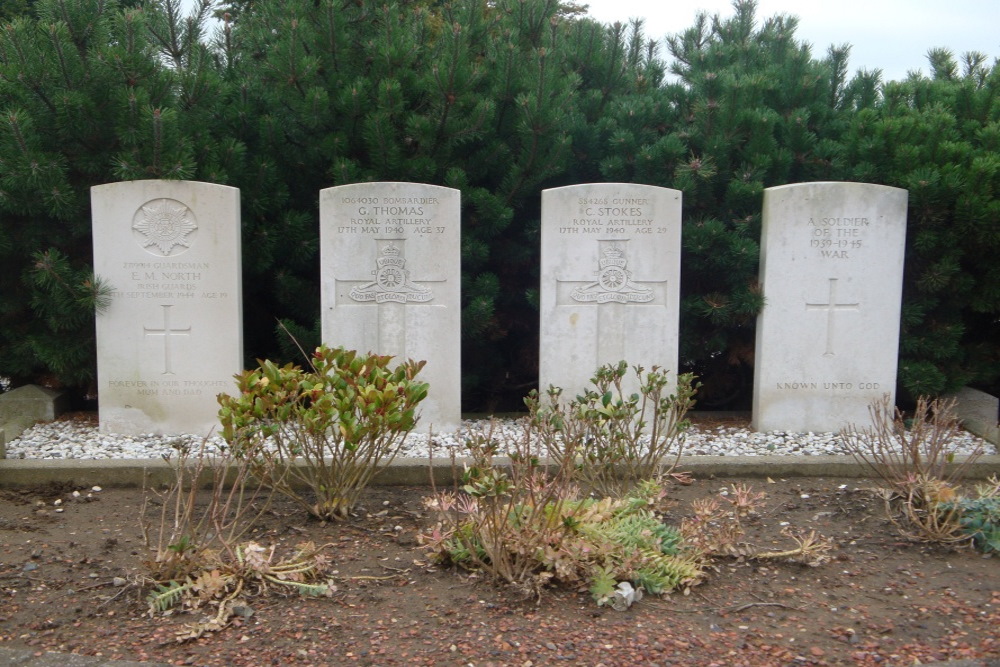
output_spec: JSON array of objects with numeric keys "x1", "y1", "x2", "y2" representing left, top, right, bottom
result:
[{"x1": 844, "y1": 49, "x2": 1000, "y2": 398}]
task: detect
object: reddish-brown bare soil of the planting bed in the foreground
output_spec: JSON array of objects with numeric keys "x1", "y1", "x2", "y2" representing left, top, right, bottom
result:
[{"x1": 0, "y1": 472, "x2": 1000, "y2": 667}]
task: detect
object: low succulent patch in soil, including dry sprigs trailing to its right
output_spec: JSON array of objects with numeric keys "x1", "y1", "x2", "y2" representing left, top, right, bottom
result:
[{"x1": 423, "y1": 447, "x2": 833, "y2": 605}]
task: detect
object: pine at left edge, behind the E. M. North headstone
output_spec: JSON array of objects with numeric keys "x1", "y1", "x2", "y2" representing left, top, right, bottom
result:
[{"x1": 0, "y1": 0, "x2": 221, "y2": 394}]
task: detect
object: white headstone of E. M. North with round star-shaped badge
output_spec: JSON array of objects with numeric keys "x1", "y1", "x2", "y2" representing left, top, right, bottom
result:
[{"x1": 91, "y1": 181, "x2": 243, "y2": 435}]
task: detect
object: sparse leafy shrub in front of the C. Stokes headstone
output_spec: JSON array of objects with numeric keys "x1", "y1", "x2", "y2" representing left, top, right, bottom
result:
[{"x1": 525, "y1": 361, "x2": 698, "y2": 497}]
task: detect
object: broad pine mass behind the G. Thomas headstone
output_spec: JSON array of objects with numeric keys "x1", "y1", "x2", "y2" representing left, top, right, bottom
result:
[{"x1": 224, "y1": 0, "x2": 592, "y2": 405}]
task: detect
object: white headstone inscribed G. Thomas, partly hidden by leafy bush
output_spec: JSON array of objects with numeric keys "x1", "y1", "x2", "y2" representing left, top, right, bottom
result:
[{"x1": 320, "y1": 183, "x2": 462, "y2": 432}]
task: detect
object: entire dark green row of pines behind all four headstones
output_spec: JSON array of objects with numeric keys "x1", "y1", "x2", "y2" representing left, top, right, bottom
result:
[{"x1": 0, "y1": 0, "x2": 1000, "y2": 410}]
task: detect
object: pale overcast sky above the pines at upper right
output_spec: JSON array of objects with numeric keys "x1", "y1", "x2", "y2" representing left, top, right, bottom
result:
[{"x1": 580, "y1": 0, "x2": 1000, "y2": 81}]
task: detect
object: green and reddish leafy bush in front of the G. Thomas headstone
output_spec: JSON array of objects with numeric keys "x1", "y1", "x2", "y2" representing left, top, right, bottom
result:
[{"x1": 219, "y1": 346, "x2": 428, "y2": 520}]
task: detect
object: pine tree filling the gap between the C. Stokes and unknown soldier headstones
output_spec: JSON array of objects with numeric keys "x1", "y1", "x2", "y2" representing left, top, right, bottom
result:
[{"x1": 588, "y1": 0, "x2": 847, "y2": 407}]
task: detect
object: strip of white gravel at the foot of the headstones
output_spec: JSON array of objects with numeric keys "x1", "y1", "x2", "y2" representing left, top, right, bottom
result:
[{"x1": 7, "y1": 420, "x2": 998, "y2": 459}]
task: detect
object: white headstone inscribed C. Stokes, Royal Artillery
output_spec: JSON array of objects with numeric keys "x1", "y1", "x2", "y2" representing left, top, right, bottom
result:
[{"x1": 539, "y1": 183, "x2": 681, "y2": 397}]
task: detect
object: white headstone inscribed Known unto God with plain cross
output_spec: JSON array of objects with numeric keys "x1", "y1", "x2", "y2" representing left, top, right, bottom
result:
[{"x1": 753, "y1": 183, "x2": 907, "y2": 432}]
